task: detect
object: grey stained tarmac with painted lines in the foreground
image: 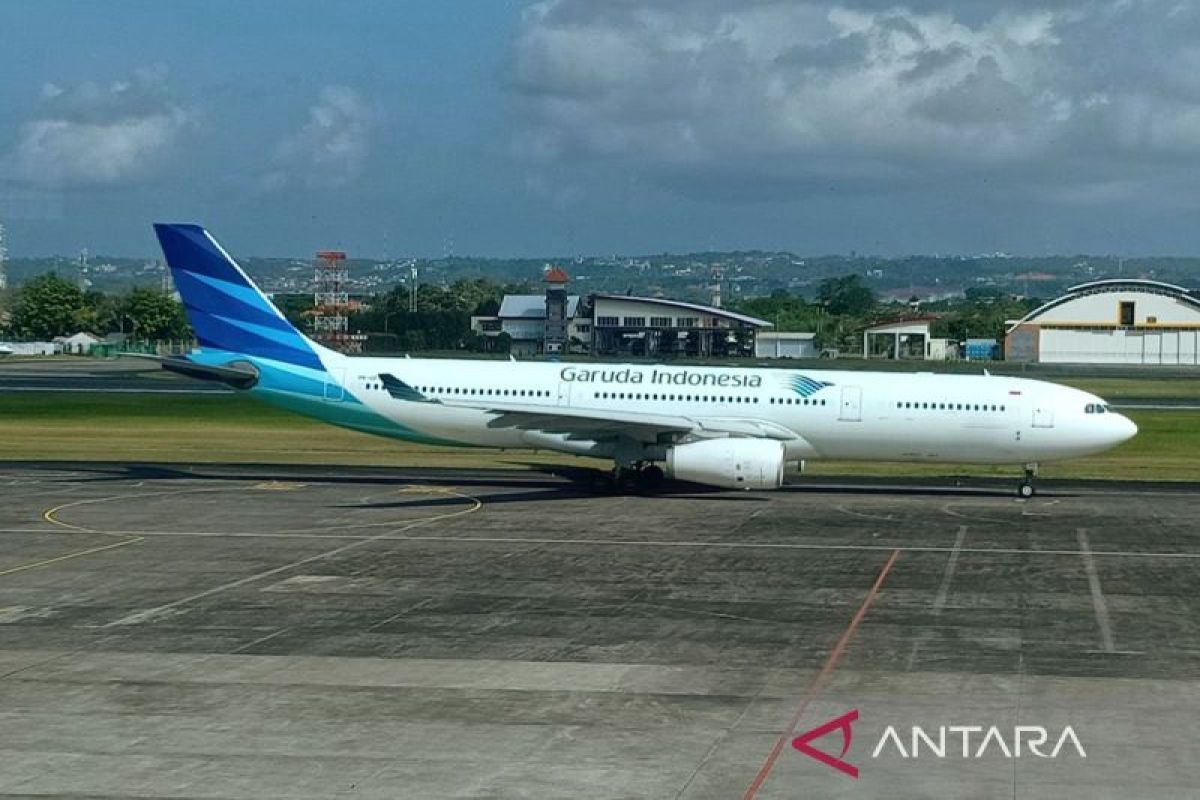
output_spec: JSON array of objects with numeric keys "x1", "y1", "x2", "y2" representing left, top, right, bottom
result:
[{"x1": 0, "y1": 463, "x2": 1200, "y2": 800}]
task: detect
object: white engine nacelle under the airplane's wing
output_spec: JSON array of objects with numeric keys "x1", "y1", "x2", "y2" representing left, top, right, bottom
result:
[{"x1": 667, "y1": 438, "x2": 784, "y2": 489}]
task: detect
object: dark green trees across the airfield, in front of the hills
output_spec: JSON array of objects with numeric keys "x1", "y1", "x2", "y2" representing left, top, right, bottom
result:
[{"x1": 0, "y1": 272, "x2": 1040, "y2": 351}]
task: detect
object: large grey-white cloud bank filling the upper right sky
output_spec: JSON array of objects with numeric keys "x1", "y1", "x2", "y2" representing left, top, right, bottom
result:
[{"x1": 515, "y1": 0, "x2": 1200, "y2": 201}]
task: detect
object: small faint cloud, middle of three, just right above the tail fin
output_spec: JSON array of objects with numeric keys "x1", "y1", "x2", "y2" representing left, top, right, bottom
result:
[{"x1": 264, "y1": 85, "x2": 376, "y2": 188}]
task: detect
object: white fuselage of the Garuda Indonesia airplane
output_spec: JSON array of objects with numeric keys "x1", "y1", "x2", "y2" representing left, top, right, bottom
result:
[{"x1": 316, "y1": 357, "x2": 1136, "y2": 464}]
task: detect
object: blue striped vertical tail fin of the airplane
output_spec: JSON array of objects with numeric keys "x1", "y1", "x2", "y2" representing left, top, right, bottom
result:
[{"x1": 154, "y1": 223, "x2": 324, "y2": 369}]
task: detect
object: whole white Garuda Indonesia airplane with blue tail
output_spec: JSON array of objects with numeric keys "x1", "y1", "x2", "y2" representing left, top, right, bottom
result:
[{"x1": 155, "y1": 223, "x2": 1138, "y2": 498}]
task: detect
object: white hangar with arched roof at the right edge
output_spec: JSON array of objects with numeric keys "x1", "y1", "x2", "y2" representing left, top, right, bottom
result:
[{"x1": 1004, "y1": 278, "x2": 1200, "y2": 365}]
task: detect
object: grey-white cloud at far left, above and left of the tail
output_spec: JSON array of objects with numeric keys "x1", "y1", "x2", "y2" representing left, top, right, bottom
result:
[{"x1": 4, "y1": 70, "x2": 188, "y2": 187}]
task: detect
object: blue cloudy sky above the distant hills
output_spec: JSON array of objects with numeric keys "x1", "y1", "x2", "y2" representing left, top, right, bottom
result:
[{"x1": 0, "y1": 0, "x2": 1200, "y2": 258}]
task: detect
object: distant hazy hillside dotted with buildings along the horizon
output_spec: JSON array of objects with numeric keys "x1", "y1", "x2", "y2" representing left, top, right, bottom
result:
[{"x1": 8, "y1": 251, "x2": 1200, "y2": 302}]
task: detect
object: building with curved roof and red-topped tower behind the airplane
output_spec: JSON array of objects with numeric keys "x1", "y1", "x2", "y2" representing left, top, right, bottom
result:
[{"x1": 472, "y1": 267, "x2": 772, "y2": 357}]
